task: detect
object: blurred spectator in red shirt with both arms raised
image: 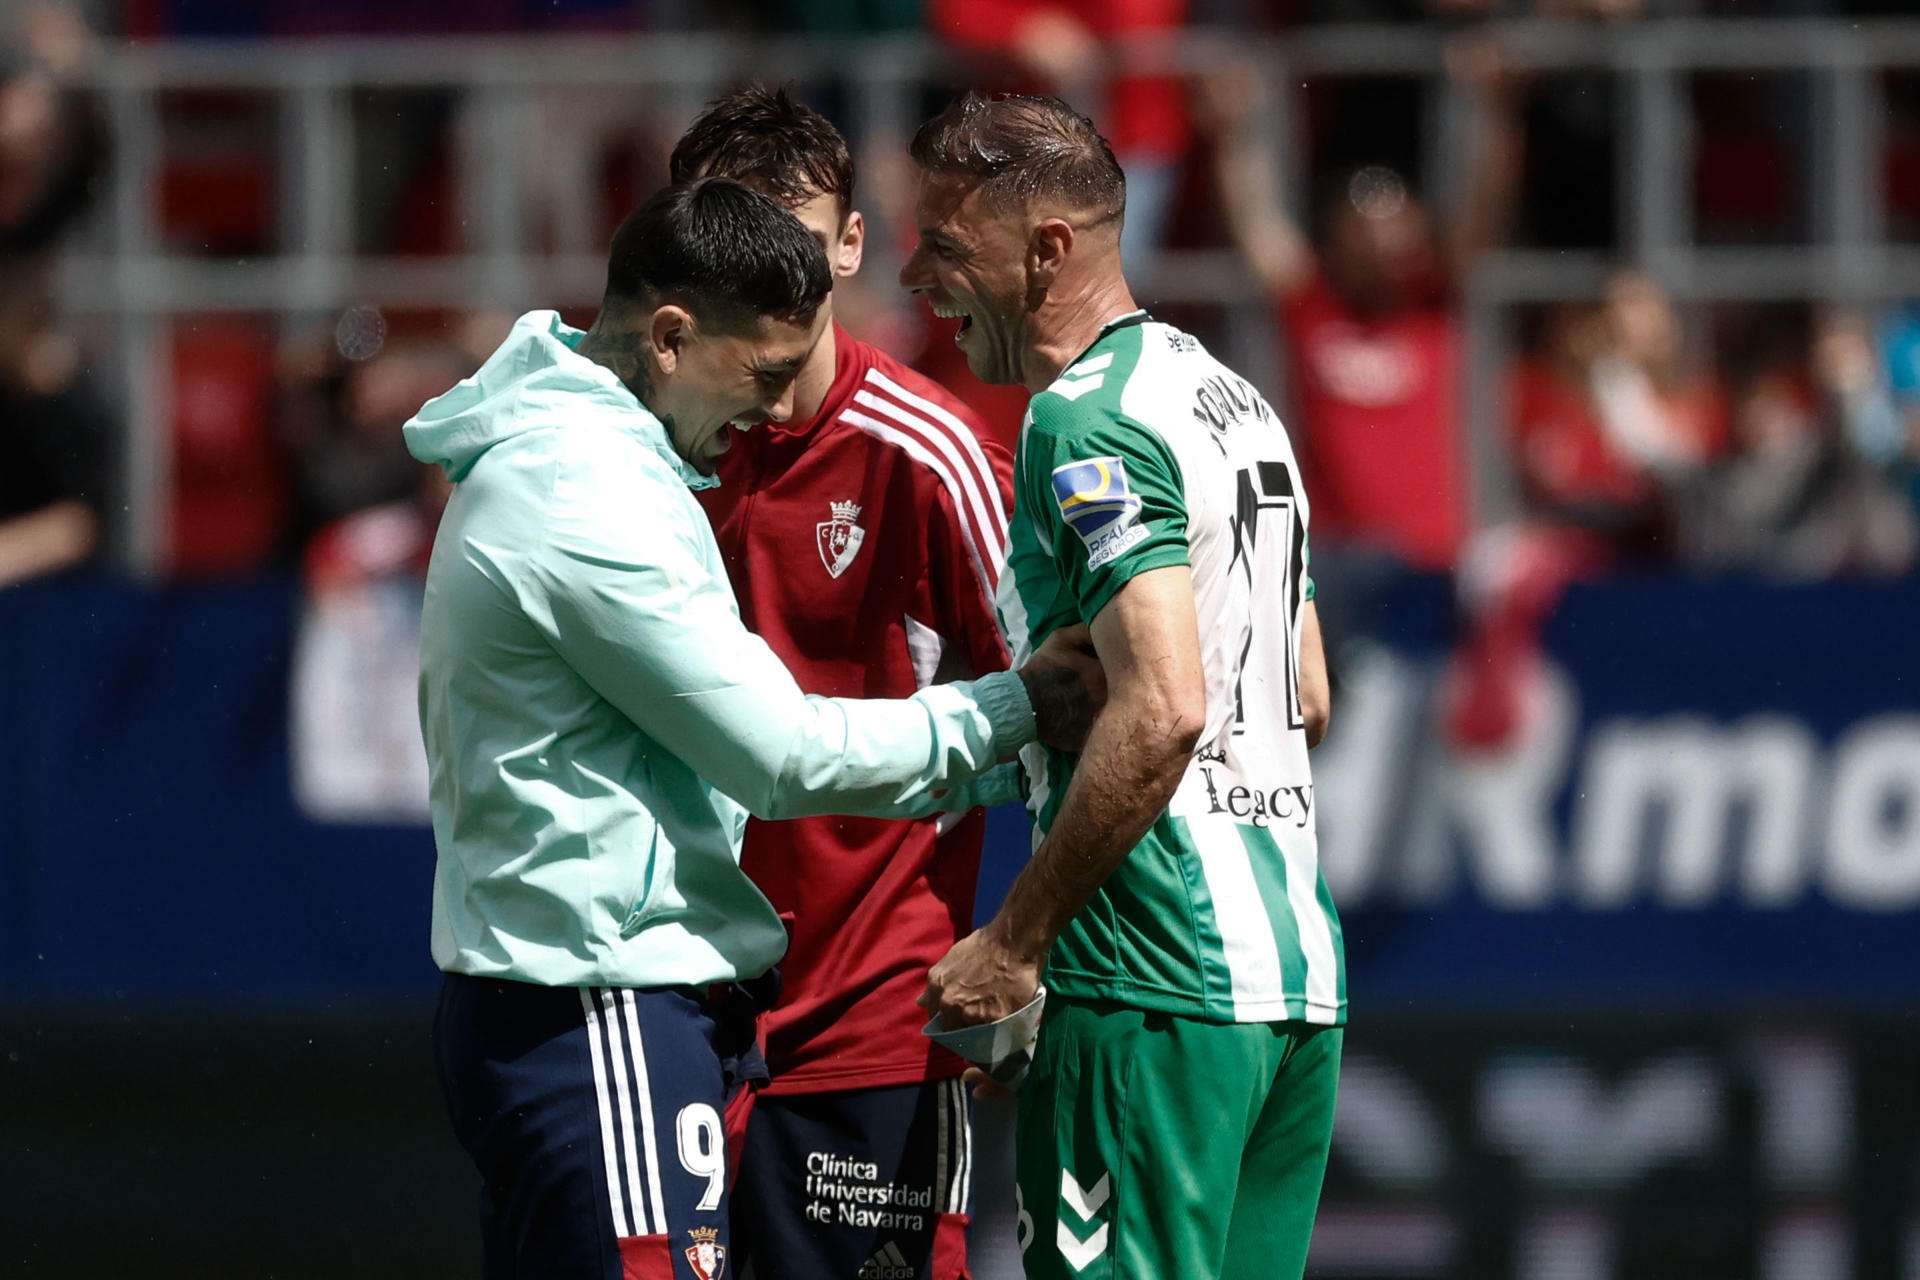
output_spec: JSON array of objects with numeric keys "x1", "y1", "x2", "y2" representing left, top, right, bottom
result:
[{"x1": 1198, "y1": 36, "x2": 1523, "y2": 575}]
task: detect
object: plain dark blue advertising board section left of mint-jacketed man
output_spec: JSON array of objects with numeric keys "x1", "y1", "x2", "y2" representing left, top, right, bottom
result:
[{"x1": 0, "y1": 580, "x2": 438, "y2": 1009}]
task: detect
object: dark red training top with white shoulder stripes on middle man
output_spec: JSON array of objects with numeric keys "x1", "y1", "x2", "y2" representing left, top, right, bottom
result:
[{"x1": 699, "y1": 324, "x2": 1012, "y2": 1094}]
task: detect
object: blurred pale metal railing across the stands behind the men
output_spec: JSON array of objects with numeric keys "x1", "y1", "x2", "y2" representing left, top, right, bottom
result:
[{"x1": 61, "y1": 19, "x2": 1920, "y2": 572}]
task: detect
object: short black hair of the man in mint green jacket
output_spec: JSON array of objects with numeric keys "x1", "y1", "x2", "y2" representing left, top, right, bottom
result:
[{"x1": 607, "y1": 178, "x2": 833, "y2": 330}]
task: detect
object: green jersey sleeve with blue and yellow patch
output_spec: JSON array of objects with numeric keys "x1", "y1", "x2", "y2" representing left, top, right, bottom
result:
[{"x1": 1020, "y1": 393, "x2": 1190, "y2": 622}]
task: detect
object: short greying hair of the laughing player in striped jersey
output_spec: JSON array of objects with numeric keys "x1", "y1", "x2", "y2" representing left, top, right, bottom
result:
[{"x1": 908, "y1": 92, "x2": 1127, "y2": 225}]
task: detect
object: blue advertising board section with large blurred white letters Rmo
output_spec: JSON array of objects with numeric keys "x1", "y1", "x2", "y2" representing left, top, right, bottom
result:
[{"x1": 1315, "y1": 578, "x2": 1920, "y2": 1007}]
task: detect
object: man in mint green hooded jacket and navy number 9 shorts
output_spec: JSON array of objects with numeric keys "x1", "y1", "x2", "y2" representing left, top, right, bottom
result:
[{"x1": 405, "y1": 180, "x2": 1085, "y2": 1280}]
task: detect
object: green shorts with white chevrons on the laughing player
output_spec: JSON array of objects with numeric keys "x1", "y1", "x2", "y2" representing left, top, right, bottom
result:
[{"x1": 1018, "y1": 996, "x2": 1342, "y2": 1280}]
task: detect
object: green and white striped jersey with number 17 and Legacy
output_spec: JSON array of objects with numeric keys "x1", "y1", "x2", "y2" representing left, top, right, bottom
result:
[{"x1": 998, "y1": 313, "x2": 1346, "y2": 1025}]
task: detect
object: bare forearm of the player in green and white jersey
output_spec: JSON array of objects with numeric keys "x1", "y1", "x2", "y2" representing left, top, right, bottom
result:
[{"x1": 987, "y1": 690, "x2": 1194, "y2": 960}]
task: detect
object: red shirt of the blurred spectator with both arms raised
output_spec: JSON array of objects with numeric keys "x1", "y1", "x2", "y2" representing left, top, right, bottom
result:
[{"x1": 1281, "y1": 273, "x2": 1467, "y2": 570}]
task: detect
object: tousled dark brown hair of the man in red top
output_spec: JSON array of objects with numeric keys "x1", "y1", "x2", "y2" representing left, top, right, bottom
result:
[{"x1": 668, "y1": 84, "x2": 854, "y2": 217}]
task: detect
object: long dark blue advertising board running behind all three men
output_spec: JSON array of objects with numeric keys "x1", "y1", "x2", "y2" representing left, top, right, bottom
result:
[{"x1": 0, "y1": 578, "x2": 1920, "y2": 1017}]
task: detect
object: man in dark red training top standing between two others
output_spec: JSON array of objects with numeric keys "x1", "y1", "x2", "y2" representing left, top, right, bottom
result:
[{"x1": 672, "y1": 86, "x2": 1012, "y2": 1280}]
